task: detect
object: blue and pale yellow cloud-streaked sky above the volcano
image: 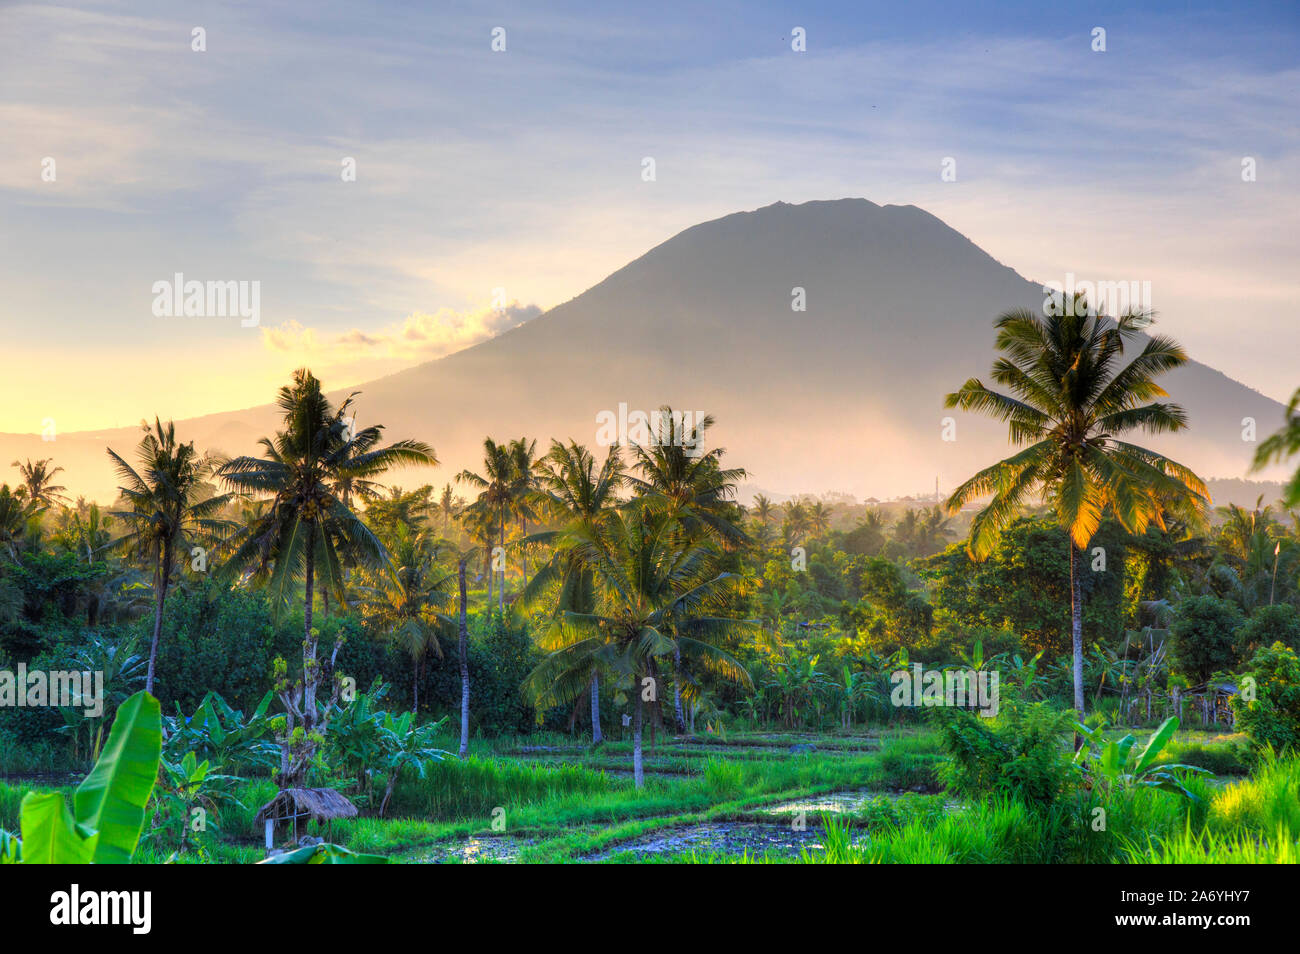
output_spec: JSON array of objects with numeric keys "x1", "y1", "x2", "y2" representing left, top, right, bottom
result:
[{"x1": 0, "y1": 0, "x2": 1300, "y2": 433}]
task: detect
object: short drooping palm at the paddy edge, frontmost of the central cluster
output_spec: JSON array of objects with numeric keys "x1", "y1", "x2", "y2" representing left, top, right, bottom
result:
[{"x1": 524, "y1": 502, "x2": 753, "y2": 788}]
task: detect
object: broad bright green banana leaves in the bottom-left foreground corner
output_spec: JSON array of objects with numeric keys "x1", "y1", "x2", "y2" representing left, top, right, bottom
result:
[{"x1": 0, "y1": 693, "x2": 163, "y2": 864}]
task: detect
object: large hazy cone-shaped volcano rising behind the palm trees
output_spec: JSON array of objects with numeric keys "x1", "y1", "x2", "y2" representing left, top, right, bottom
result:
[{"x1": 0, "y1": 199, "x2": 1283, "y2": 499}]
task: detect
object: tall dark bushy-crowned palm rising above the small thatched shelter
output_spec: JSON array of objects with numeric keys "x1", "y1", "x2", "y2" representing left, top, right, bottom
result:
[{"x1": 220, "y1": 368, "x2": 438, "y2": 759}]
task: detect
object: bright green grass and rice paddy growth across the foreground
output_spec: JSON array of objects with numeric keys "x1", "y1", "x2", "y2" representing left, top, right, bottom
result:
[{"x1": 0, "y1": 727, "x2": 1300, "y2": 864}]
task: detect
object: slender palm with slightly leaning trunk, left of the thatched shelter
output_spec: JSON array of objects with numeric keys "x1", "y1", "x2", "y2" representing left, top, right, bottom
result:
[{"x1": 108, "y1": 419, "x2": 231, "y2": 693}]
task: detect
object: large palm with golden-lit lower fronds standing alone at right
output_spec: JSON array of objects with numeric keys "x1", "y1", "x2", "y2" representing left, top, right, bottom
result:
[{"x1": 945, "y1": 304, "x2": 1208, "y2": 716}]
